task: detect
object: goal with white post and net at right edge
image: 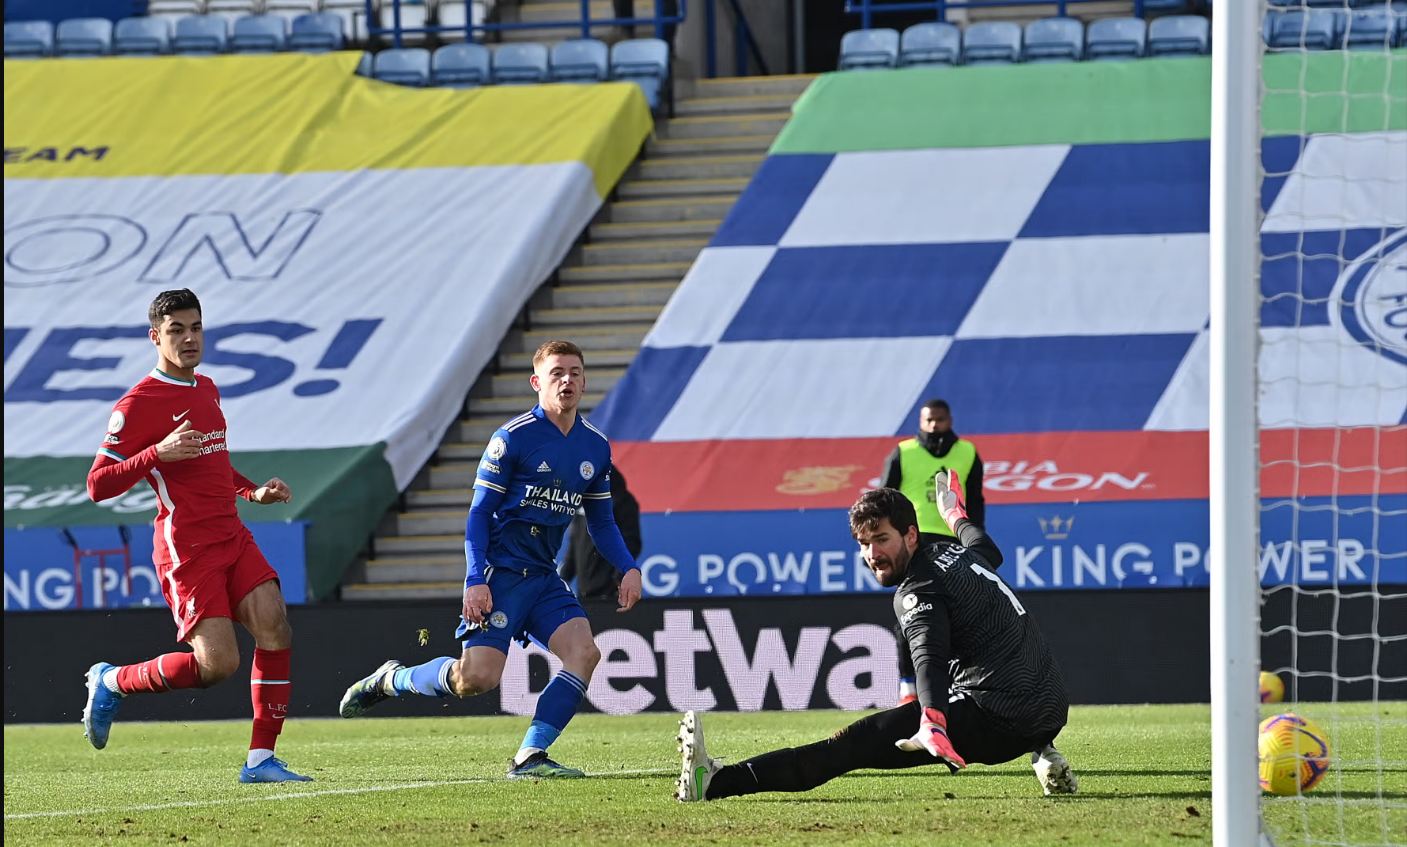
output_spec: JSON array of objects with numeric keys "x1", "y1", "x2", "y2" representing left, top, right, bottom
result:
[{"x1": 1206, "y1": 0, "x2": 1407, "y2": 847}]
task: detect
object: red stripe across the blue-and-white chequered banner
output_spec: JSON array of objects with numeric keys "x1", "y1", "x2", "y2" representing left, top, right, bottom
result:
[{"x1": 612, "y1": 426, "x2": 1407, "y2": 512}]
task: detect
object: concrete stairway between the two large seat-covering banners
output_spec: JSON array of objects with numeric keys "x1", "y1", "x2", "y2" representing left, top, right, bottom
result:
[{"x1": 342, "y1": 76, "x2": 812, "y2": 599}]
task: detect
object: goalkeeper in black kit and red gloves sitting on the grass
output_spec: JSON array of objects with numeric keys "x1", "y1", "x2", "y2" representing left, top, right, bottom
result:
[{"x1": 675, "y1": 471, "x2": 1078, "y2": 802}]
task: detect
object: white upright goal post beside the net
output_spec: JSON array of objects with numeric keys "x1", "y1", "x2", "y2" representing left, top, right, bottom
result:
[{"x1": 1207, "y1": 0, "x2": 1262, "y2": 847}]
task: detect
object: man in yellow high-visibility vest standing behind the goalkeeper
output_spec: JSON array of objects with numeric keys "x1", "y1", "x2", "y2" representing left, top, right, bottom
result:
[{"x1": 881, "y1": 400, "x2": 986, "y2": 545}]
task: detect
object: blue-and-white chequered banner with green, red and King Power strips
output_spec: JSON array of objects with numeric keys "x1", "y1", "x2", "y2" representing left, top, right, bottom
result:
[{"x1": 592, "y1": 52, "x2": 1407, "y2": 597}]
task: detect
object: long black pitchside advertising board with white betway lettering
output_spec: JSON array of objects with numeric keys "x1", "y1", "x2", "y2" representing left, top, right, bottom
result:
[{"x1": 4, "y1": 590, "x2": 1384, "y2": 717}]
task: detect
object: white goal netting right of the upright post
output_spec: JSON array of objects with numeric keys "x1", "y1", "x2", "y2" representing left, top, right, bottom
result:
[{"x1": 1217, "y1": 0, "x2": 1407, "y2": 847}]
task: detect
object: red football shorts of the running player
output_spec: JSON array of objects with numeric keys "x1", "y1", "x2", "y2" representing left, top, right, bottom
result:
[{"x1": 156, "y1": 526, "x2": 279, "y2": 642}]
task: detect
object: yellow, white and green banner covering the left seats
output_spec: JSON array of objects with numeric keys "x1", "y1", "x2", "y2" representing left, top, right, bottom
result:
[{"x1": 4, "y1": 52, "x2": 651, "y2": 597}]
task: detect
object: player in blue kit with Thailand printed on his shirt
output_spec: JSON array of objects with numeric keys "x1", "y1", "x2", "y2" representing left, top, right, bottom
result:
[{"x1": 339, "y1": 340, "x2": 640, "y2": 778}]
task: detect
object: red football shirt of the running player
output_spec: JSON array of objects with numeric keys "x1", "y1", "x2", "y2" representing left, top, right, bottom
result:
[{"x1": 89, "y1": 370, "x2": 253, "y2": 566}]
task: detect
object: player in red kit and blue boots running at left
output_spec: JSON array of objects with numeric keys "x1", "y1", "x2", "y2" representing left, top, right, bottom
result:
[{"x1": 83, "y1": 288, "x2": 311, "y2": 782}]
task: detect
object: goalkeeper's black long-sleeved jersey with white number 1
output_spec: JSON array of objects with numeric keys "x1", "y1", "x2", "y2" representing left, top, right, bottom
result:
[{"x1": 893, "y1": 521, "x2": 1069, "y2": 737}]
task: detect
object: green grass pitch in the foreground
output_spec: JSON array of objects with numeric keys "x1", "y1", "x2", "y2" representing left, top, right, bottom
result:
[{"x1": 4, "y1": 702, "x2": 1407, "y2": 847}]
